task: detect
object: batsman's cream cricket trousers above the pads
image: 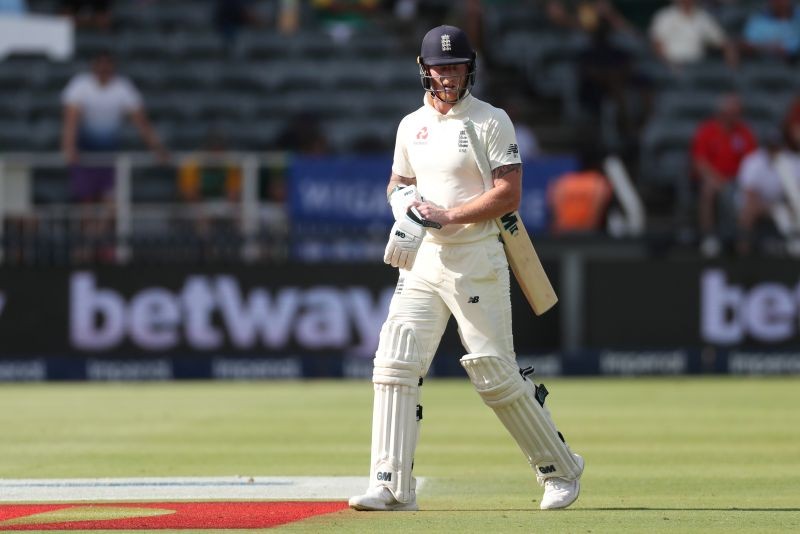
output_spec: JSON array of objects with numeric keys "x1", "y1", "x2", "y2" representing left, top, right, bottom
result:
[{"x1": 387, "y1": 236, "x2": 515, "y2": 376}]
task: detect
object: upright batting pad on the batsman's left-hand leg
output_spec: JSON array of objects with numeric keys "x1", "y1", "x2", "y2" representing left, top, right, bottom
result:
[{"x1": 370, "y1": 321, "x2": 422, "y2": 503}]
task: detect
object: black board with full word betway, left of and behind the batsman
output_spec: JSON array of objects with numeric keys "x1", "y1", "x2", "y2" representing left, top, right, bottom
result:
[{"x1": 0, "y1": 264, "x2": 558, "y2": 380}]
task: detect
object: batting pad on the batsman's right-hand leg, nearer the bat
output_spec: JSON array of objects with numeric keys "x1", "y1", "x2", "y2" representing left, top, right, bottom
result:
[{"x1": 461, "y1": 354, "x2": 581, "y2": 483}]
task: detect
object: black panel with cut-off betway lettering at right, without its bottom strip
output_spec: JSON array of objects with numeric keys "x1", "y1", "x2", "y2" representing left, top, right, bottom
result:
[{"x1": 584, "y1": 259, "x2": 800, "y2": 351}]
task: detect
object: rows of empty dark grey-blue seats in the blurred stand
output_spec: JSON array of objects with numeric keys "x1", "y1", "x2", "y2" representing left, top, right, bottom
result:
[{"x1": 0, "y1": 0, "x2": 800, "y2": 241}]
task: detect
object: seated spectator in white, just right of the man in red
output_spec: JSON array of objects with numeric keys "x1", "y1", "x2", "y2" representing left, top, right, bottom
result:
[{"x1": 737, "y1": 129, "x2": 800, "y2": 256}]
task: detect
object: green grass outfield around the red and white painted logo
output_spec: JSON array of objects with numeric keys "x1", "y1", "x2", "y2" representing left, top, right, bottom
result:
[{"x1": 0, "y1": 377, "x2": 800, "y2": 533}]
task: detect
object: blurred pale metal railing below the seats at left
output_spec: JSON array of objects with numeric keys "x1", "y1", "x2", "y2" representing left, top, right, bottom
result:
[{"x1": 0, "y1": 152, "x2": 288, "y2": 263}]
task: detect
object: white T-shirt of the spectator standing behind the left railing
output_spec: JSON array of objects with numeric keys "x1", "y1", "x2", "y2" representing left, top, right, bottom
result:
[{"x1": 61, "y1": 73, "x2": 142, "y2": 139}]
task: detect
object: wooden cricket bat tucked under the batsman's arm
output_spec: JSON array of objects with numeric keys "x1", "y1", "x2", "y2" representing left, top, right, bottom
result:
[{"x1": 464, "y1": 120, "x2": 558, "y2": 315}]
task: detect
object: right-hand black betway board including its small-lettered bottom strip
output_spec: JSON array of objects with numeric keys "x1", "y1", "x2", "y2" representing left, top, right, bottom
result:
[{"x1": 582, "y1": 259, "x2": 800, "y2": 374}]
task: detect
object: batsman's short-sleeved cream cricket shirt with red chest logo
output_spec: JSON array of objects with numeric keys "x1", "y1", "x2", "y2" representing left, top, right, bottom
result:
[{"x1": 392, "y1": 94, "x2": 522, "y2": 244}]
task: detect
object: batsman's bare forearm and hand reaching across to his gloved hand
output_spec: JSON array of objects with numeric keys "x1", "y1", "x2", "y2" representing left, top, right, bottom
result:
[{"x1": 415, "y1": 163, "x2": 522, "y2": 225}]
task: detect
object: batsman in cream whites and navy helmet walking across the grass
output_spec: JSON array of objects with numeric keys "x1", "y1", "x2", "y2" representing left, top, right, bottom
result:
[{"x1": 350, "y1": 26, "x2": 584, "y2": 511}]
